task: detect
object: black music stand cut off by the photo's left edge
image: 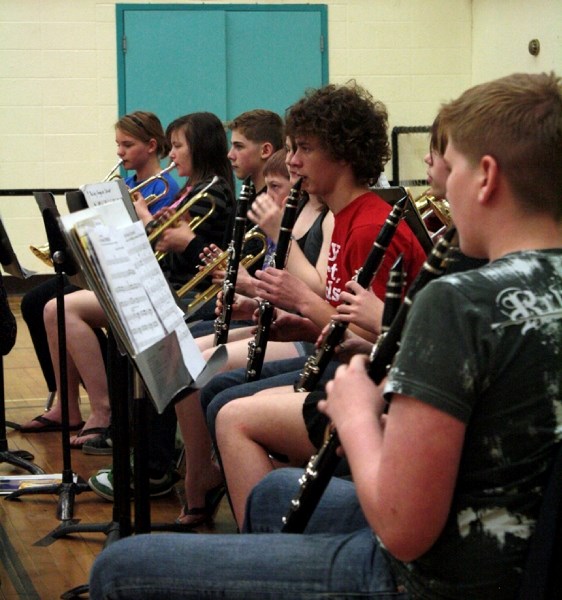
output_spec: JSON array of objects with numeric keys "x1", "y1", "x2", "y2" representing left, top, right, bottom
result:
[{"x1": 0, "y1": 219, "x2": 45, "y2": 475}]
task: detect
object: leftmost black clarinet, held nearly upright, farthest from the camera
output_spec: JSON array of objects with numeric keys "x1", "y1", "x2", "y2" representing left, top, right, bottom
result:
[{"x1": 214, "y1": 177, "x2": 255, "y2": 346}]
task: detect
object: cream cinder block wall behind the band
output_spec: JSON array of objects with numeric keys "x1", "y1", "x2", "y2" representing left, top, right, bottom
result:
[{"x1": 0, "y1": 0, "x2": 562, "y2": 272}]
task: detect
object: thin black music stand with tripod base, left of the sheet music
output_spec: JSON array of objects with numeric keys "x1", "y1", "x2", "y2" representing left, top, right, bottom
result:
[{"x1": 6, "y1": 192, "x2": 91, "y2": 521}]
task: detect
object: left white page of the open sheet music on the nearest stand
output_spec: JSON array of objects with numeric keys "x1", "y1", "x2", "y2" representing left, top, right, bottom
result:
[{"x1": 87, "y1": 225, "x2": 165, "y2": 354}]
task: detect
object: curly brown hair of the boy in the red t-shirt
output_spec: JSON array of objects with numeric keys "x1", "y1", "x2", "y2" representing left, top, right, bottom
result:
[{"x1": 285, "y1": 81, "x2": 390, "y2": 184}]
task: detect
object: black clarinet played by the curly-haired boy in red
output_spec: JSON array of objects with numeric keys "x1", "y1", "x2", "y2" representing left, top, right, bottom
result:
[{"x1": 246, "y1": 177, "x2": 302, "y2": 381}]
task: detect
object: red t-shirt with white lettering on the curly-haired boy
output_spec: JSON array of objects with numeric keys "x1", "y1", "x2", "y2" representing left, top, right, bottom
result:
[{"x1": 326, "y1": 192, "x2": 426, "y2": 306}]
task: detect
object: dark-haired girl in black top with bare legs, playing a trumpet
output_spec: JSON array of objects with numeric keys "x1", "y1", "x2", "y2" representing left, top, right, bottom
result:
[{"x1": 19, "y1": 113, "x2": 234, "y2": 454}]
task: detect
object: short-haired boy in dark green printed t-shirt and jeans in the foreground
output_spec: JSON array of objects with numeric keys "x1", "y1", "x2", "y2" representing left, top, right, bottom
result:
[{"x1": 90, "y1": 74, "x2": 562, "y2": 600}]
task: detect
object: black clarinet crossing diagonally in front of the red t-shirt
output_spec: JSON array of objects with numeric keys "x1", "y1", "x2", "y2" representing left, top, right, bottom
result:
[{"x1": 294, "y1": 195, "x2": 408, "y2": 392}]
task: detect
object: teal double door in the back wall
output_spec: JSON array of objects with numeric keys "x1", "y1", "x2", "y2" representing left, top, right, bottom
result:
[{"x1": 116, "y1": 4, "x2": 328, "y2": 132}]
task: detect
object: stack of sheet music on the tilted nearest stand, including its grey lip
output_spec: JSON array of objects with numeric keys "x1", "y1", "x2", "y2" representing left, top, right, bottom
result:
[{"x1": 61, "y1": 203, "x2": 212, "y2": 412}]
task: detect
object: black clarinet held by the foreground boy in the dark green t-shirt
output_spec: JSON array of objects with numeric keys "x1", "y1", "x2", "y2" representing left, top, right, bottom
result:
[{"x1": 281, "y1": 227, "x2": 456, "y2": 533}]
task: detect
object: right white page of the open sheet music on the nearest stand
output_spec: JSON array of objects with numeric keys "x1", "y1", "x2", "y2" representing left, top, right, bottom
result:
[{"x1": 122, "y1": 222, "x2": 205, "y2": 379}]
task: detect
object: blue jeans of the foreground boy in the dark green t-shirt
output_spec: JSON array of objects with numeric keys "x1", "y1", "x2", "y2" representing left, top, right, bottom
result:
[{"x1": 90, "y1": 469, "x2": 407, "y2": 600}]
